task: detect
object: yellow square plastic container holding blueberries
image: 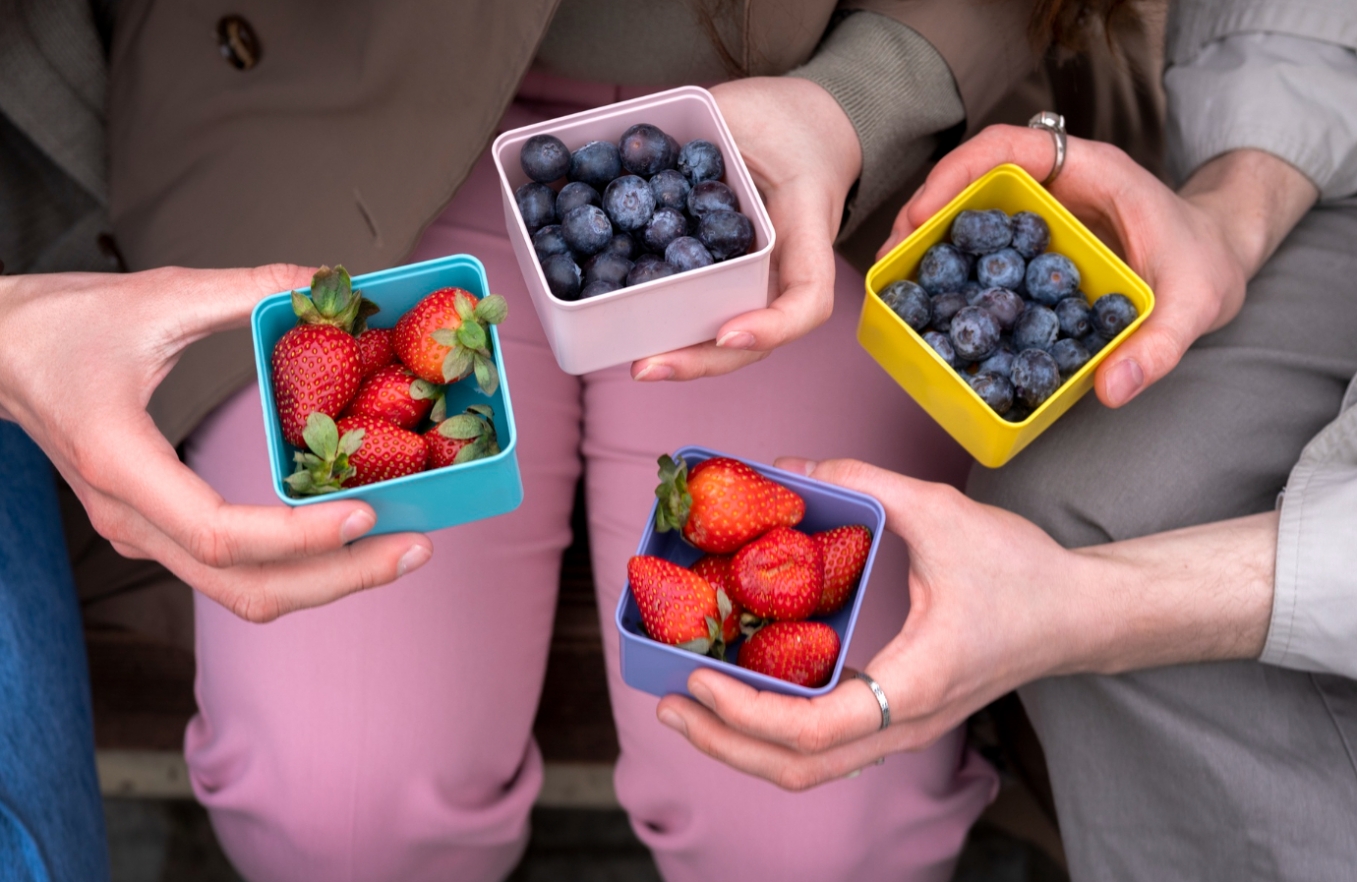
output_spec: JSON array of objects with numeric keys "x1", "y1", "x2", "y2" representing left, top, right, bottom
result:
[{"x1": 858, "y1": 164, "x2": 1155, "y2": 468}]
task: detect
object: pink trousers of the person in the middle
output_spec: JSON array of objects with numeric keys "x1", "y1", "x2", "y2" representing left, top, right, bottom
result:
[{"x1": 186, "y1": 77, "x2": 995, "y2": 882}]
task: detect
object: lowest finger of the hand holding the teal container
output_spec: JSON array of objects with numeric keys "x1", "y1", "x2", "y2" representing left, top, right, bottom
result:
[{"x1": 152, "y1": 533, "x2": 433, "y2": 621}]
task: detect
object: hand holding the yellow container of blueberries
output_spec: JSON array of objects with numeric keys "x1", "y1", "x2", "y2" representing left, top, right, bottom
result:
[{"x1": 878, "y1": 126, "x2": 1318, "y2": 407}]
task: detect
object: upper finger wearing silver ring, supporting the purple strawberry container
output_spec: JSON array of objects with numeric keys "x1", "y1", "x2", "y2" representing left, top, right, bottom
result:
[{"x1": 688, "y1": 669, "x2": 881, "y2": 753}]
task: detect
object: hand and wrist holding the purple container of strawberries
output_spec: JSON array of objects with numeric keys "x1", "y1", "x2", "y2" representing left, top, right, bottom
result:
[{"x1": 657, "y1": 460, "x2": 1277, "y2": 790}]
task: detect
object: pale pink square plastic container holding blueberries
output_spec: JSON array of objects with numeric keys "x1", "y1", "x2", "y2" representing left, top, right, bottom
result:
[{"x1": 491, "y1": 85, "x2": 773, "y2": 375}]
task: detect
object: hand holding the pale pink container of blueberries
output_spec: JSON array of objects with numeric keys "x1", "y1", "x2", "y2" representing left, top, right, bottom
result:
[{"x1": 631, "y1": 77, "x2": 862, "y2": 380}]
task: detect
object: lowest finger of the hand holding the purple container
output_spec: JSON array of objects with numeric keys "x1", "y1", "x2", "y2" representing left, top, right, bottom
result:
[{"x1": 657, "y1": 695, "x2": 889, "y2": 791}]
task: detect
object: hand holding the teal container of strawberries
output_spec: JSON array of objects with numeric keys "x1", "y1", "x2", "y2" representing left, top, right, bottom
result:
[{"x1": 0, "y1": 266, "x2": 432, "y2": 621}]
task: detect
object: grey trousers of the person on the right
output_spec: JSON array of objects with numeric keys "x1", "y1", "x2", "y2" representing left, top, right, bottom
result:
[{"x1": 969, "y1": 199, "x2": 1357, "y2": 882}]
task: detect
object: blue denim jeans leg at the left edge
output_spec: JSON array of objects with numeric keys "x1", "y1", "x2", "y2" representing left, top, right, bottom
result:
[{"x1": 0, "y1": 419, "x2": 109, "y2": 882}]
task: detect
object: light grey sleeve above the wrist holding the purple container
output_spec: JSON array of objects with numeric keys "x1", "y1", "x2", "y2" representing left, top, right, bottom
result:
[{"x1": 1259, "y1": 393, "x2": 1357, "y2": 678}]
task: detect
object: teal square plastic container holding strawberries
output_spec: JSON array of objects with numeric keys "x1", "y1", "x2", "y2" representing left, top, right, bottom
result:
[{"x1": 251, "y1": 254, "x2": 522, "y2": 535}]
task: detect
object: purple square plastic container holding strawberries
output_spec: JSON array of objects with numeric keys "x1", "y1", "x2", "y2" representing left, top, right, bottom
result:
[{"x1": 616, "y1": 446, "x2": 886, "y2": 697}]
